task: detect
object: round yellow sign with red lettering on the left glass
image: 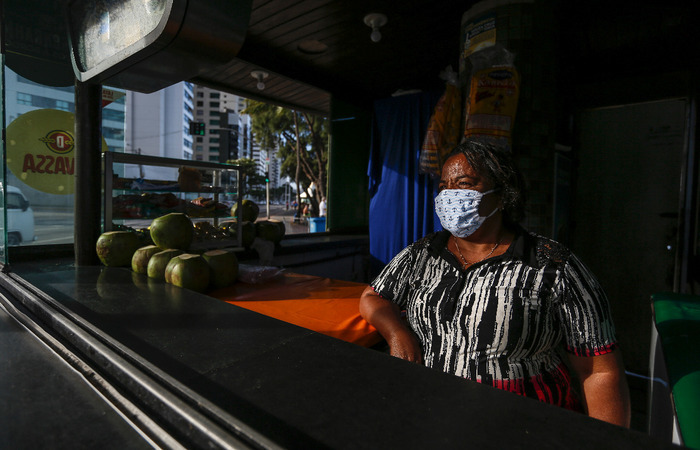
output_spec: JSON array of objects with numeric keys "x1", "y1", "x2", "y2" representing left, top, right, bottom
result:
[{"x1": 7, "y1": 109, "x2": 107, "y2": 195}]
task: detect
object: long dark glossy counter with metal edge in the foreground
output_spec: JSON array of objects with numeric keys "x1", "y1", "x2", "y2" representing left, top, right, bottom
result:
[{"x1": 0, "y1": 256, "x2": 680, "y2": 449}]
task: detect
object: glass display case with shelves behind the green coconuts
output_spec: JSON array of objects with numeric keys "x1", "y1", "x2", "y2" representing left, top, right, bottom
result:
[{"x1": 103, "y1": 152, "x2": 243, "y2": 249}]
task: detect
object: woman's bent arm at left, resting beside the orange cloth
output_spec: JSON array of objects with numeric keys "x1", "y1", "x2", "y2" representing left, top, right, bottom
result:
[{"x1": 360, "y1": 286, "x2": 423, "y2": 364}]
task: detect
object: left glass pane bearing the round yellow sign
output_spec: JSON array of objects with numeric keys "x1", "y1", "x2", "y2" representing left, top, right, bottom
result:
[{"x1": 0, "y1": 66, "x2": 82, "y2": 251}]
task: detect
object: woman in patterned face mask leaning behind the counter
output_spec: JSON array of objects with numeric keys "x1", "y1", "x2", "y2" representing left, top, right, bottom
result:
[{"x1": 360, "y1": 141, "x2": 630, "y2": 426}]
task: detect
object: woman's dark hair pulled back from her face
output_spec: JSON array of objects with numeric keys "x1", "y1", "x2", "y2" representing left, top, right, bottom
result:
[{"x1": 445, "y1": 140, "x2": 525, "y2": 225}]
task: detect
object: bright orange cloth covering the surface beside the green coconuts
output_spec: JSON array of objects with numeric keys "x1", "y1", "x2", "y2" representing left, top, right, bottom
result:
[{"x1": 209, "y1": 273, "x2": 382, "y2": 347}]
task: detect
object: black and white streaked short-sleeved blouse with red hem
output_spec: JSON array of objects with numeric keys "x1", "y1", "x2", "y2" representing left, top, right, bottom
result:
[{"x1": 371, "y1": 230, "x2": 616, "y2": 409}]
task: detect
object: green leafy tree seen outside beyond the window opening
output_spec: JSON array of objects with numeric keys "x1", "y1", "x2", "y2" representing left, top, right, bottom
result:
[{"x1": 242, "y1": 100, "x2": 329, "y2": 215}]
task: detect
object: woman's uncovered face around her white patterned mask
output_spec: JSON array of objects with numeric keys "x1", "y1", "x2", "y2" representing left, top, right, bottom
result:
[{"x1": 438, "y1": 154, "x2": 501, "y2": 216}]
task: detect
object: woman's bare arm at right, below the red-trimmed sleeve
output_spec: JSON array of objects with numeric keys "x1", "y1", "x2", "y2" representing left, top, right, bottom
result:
[{"x1": 569, "y1": 350, "x2": 631, "y2": 428}]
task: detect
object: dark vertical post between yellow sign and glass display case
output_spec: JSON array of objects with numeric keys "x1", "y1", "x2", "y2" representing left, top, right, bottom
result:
[{"x1": 73, "y1": 81, "x2": 102, "y2": 266}]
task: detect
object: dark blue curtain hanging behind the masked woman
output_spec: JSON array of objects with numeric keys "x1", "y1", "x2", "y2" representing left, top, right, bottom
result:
[{"x1": 368, "y1": 92, "x2": 441, "y2": 277}]
